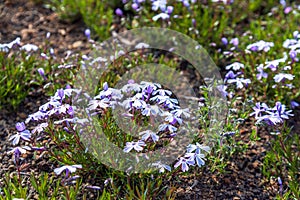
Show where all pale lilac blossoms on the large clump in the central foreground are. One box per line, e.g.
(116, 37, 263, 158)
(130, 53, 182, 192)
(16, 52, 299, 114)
(10, 77, 209, 177)
